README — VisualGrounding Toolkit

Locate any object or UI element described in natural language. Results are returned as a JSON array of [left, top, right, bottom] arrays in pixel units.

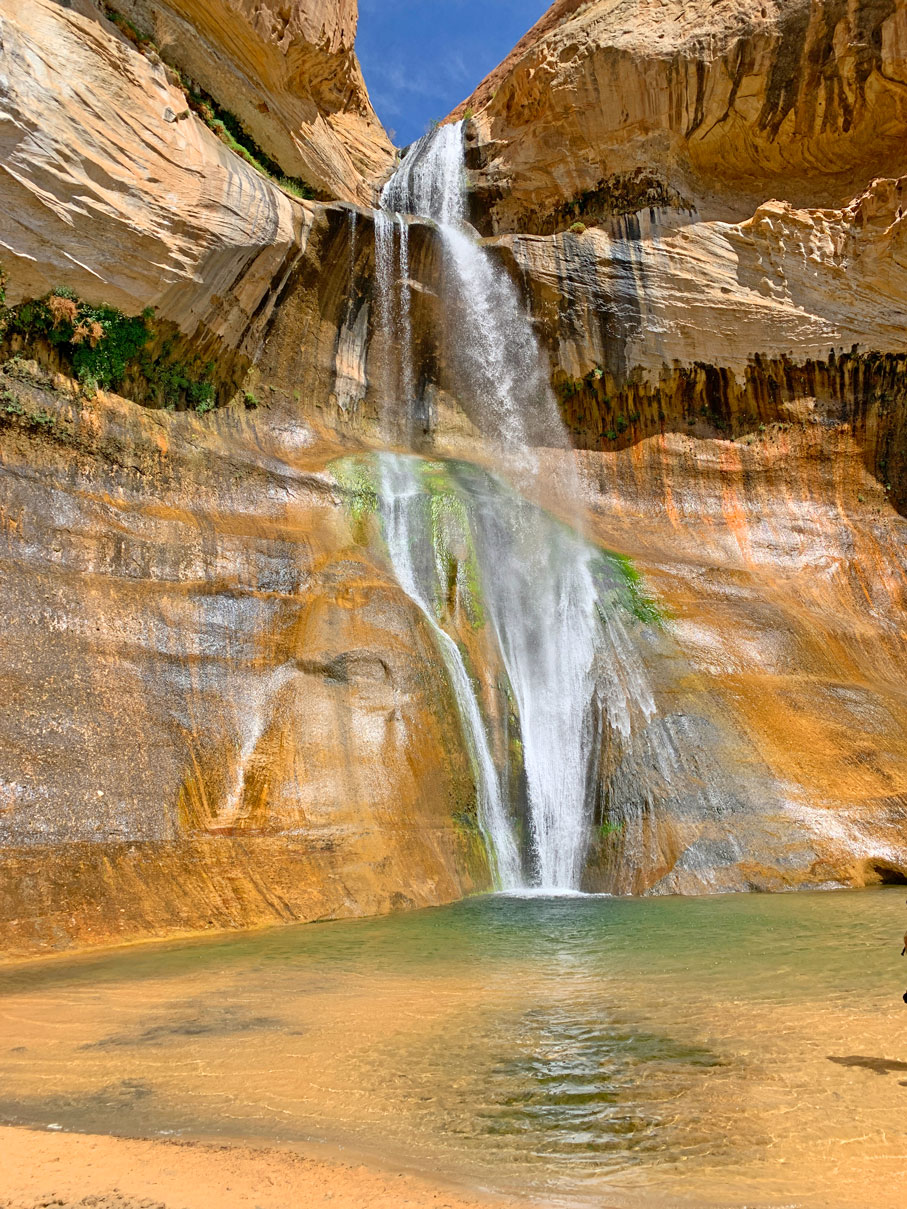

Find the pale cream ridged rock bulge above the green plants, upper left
[[0, 0, 298, 353]]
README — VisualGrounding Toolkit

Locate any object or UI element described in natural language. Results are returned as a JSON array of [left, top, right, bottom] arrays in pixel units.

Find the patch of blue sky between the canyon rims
[[356, 0, 550, 146]]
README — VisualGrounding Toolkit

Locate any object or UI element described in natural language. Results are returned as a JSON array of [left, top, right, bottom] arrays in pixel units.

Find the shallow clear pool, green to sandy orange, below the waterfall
[[0, 889, 907, 1209]]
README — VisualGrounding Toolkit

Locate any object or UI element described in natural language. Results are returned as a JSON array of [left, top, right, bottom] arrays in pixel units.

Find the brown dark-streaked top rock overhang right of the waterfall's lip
[[458, 0, 907, 232]]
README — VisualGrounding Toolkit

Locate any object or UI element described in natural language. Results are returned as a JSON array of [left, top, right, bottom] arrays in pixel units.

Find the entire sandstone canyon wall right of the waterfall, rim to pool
[[445, 0, 907, 891]]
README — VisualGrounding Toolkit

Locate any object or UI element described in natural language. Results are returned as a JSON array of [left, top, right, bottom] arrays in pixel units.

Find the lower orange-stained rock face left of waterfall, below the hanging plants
[[0, 366, 487, 953]]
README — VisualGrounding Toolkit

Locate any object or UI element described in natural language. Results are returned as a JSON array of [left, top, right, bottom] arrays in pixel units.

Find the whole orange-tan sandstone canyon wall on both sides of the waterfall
[[0, 0, 907, 953]]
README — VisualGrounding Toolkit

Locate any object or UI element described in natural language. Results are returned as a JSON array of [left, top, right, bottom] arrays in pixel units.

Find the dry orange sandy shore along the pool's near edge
[[0, 1126, 525, 1209]]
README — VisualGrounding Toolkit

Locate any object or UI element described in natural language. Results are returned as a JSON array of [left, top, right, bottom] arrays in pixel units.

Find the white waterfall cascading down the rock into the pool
[[376, 125, 653, 891]]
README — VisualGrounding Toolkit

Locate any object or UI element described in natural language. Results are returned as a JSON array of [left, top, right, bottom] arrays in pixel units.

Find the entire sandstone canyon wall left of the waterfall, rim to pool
[[0, 0, 489, 954]]
